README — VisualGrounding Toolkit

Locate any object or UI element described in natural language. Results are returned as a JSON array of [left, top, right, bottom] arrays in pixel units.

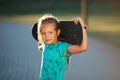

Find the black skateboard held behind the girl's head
[[32, 21, 83, 45]]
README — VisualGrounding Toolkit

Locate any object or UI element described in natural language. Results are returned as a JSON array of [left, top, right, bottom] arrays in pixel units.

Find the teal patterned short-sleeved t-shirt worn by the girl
[[40, 41, 72, 80]]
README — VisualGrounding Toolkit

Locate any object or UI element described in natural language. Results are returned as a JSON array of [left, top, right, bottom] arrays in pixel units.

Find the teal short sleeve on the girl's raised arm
[[60, 42, 72, 58]]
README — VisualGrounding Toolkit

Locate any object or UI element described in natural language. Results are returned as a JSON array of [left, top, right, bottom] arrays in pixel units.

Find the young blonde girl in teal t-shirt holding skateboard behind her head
[[38, 15, 88, 80]]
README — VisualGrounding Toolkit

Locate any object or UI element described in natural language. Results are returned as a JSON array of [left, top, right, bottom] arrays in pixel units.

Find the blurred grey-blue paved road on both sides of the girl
[[0, 22, 120, 80]]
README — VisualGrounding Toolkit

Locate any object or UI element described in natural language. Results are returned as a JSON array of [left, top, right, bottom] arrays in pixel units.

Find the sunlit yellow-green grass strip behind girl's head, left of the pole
[[0, 14, 79, 24]]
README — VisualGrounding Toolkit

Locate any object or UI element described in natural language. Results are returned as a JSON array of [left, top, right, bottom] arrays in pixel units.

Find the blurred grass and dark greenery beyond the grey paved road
[[0, 0, 120, 46]]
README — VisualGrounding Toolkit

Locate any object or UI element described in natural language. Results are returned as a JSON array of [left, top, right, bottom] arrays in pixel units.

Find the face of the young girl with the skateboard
[[40, 23, 60, 44]]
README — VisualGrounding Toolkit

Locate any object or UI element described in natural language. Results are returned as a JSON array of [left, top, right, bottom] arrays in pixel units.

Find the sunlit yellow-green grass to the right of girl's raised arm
[[88, 16, 120, 47]]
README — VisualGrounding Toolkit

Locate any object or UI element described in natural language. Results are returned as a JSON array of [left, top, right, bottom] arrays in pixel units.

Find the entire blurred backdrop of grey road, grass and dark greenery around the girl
[[0, 0, 120, 80]]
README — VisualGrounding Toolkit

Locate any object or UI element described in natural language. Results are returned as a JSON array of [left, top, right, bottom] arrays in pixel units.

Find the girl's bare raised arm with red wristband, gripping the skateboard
[[68, 17, 88, 54]]
